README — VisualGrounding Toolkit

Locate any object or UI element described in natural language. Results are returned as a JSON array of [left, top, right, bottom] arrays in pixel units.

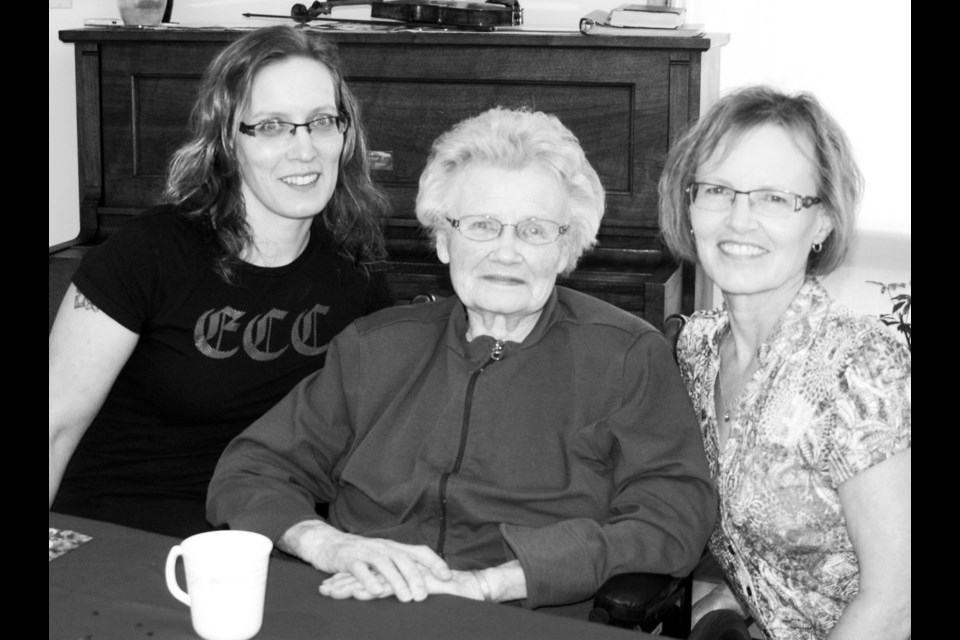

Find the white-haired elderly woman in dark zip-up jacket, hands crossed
[[207, 109, 716, 615]]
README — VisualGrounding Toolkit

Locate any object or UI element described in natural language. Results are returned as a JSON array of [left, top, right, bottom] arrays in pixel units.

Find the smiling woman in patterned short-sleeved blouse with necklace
[[660, 87, 911, 640]]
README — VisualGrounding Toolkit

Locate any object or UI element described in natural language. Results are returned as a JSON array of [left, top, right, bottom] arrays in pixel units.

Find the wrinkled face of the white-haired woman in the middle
[[437, 164, 568, 319]]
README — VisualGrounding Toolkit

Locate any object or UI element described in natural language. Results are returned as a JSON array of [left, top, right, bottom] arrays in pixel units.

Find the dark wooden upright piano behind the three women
[[59, 24, 728, 327]]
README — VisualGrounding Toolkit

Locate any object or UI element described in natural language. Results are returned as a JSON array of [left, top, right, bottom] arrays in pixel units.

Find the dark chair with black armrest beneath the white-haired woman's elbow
[[589, 314, 751, 640]]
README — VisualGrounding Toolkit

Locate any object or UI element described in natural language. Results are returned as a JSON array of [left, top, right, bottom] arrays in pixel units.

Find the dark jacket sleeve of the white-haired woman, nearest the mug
[[207, 325, 356, 542]]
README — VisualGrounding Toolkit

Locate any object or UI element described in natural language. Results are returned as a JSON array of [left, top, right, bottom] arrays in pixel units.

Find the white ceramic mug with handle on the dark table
[[166, 530, 273, 640]]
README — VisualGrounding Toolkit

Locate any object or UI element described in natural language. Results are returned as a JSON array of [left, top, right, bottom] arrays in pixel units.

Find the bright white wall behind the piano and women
[[49, 0, 911, 313]]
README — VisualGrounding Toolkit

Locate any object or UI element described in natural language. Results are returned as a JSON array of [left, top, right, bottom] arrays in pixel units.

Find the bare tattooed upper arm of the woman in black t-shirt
[[48, 284, 139, 507]]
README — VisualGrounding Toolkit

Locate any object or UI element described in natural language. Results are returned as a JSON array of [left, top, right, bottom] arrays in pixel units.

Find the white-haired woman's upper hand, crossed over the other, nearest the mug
[[277, 520, 452, 602]]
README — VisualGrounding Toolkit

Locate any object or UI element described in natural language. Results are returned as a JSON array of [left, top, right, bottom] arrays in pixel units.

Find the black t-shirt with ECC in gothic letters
[[52, 208, 393, 537]]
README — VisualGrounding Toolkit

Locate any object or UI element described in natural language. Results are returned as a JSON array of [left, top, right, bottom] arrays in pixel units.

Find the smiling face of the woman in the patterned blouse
[[690, 124, 833, 295]]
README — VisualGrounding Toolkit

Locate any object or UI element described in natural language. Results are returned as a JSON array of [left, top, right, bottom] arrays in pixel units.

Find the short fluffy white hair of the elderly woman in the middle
[[416, 107, 604, 275]]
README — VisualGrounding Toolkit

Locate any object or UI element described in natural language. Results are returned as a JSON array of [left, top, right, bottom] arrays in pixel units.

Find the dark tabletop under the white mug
[[49, 513, 654, 640]]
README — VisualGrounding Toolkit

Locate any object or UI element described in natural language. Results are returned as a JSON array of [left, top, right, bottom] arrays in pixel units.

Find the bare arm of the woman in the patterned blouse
[[830, 449, 911, 640]]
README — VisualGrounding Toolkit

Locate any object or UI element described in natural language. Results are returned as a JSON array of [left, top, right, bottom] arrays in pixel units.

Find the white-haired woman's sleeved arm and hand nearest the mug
[[207, 341, 451, 602]]
